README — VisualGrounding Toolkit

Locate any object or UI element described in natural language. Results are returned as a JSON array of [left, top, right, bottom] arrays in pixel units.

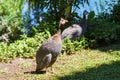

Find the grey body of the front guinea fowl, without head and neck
[[36, 32, 62, 70]]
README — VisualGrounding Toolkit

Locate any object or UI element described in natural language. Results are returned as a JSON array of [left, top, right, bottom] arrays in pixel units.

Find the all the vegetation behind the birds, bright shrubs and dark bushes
[[0, 0, 120, 61]]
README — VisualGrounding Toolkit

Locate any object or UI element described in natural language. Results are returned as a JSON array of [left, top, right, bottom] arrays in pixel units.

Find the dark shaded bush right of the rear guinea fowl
[[86, 14, 120, 45]]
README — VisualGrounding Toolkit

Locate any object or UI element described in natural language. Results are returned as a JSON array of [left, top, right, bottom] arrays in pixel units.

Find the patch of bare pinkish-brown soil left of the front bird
[[0, 58, 36, 80]]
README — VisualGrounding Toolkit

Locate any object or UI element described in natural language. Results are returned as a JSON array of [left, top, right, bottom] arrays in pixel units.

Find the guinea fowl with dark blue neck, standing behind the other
[[62, 10, 88, 41]]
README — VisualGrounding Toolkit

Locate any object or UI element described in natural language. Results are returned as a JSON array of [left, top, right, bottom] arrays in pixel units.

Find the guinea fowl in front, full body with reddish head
[[36, 18, 68, 72]]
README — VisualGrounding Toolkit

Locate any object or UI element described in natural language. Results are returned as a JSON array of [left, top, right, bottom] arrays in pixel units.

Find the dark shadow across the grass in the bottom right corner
[[58, 61, 120, 80]]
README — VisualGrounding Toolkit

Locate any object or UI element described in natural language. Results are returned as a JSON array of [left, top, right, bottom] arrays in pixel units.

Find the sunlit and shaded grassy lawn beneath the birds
[[0, 44, 120, 80]]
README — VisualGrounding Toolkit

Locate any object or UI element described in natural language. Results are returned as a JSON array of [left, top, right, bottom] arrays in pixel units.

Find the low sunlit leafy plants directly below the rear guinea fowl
[[62, 36, 89, 55]]
